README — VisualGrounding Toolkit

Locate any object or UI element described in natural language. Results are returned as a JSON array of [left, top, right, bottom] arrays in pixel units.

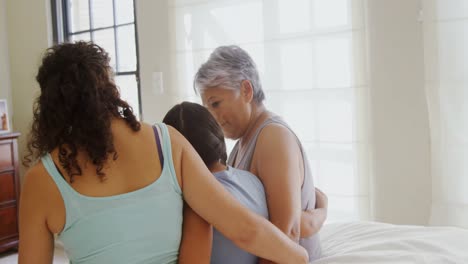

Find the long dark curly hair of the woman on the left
[[23, 41, 141, 182]]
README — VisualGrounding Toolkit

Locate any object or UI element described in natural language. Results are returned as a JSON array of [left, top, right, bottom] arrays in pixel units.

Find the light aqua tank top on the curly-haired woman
[[42, 124, 183, 264]]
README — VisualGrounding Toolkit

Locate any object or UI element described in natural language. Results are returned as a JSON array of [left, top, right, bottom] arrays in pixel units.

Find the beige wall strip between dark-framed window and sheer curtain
[[136, 0, 179, 123]]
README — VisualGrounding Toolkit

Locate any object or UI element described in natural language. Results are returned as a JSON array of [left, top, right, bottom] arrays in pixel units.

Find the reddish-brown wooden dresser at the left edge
[[0, 133, 20, 252]]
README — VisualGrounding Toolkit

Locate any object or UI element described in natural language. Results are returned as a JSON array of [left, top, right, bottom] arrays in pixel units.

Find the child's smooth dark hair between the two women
[[163, 102, 227, 167]]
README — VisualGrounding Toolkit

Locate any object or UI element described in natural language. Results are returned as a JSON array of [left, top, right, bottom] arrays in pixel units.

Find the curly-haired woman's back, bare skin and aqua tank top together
[[34, 121, 183, 263]]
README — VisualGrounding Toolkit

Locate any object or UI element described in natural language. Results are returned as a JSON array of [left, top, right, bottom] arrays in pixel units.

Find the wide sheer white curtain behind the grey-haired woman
[[169, 0, 370, 220]]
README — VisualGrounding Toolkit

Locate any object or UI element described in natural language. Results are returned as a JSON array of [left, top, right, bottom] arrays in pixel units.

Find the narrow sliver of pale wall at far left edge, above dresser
[[0, 0, 13, 120]]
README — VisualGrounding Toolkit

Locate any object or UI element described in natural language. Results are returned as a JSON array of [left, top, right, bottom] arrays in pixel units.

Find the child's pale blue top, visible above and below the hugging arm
[[211, 167, 268, 264]]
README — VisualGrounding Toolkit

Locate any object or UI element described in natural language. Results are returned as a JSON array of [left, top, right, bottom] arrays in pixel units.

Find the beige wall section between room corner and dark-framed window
[[2, 0, 51, 178]]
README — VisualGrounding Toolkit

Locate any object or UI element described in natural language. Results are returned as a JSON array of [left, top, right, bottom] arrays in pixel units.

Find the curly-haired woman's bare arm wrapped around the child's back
[[169, 128, 308, 263]]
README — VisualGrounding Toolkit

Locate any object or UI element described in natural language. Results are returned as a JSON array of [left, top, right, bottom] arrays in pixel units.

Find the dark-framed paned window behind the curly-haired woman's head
[[52, 0, 141, 118]]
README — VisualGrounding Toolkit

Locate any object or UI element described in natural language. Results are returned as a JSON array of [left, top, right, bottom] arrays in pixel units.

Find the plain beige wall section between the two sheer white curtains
[[367, 0, 431, 224]]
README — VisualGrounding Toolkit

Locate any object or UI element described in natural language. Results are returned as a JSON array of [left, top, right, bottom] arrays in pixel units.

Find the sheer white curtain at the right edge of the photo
[[423, 0, 468, 228]]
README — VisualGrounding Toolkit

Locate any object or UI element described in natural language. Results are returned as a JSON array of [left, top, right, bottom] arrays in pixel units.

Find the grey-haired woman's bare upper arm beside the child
[[252, 125, 304, 263]]
